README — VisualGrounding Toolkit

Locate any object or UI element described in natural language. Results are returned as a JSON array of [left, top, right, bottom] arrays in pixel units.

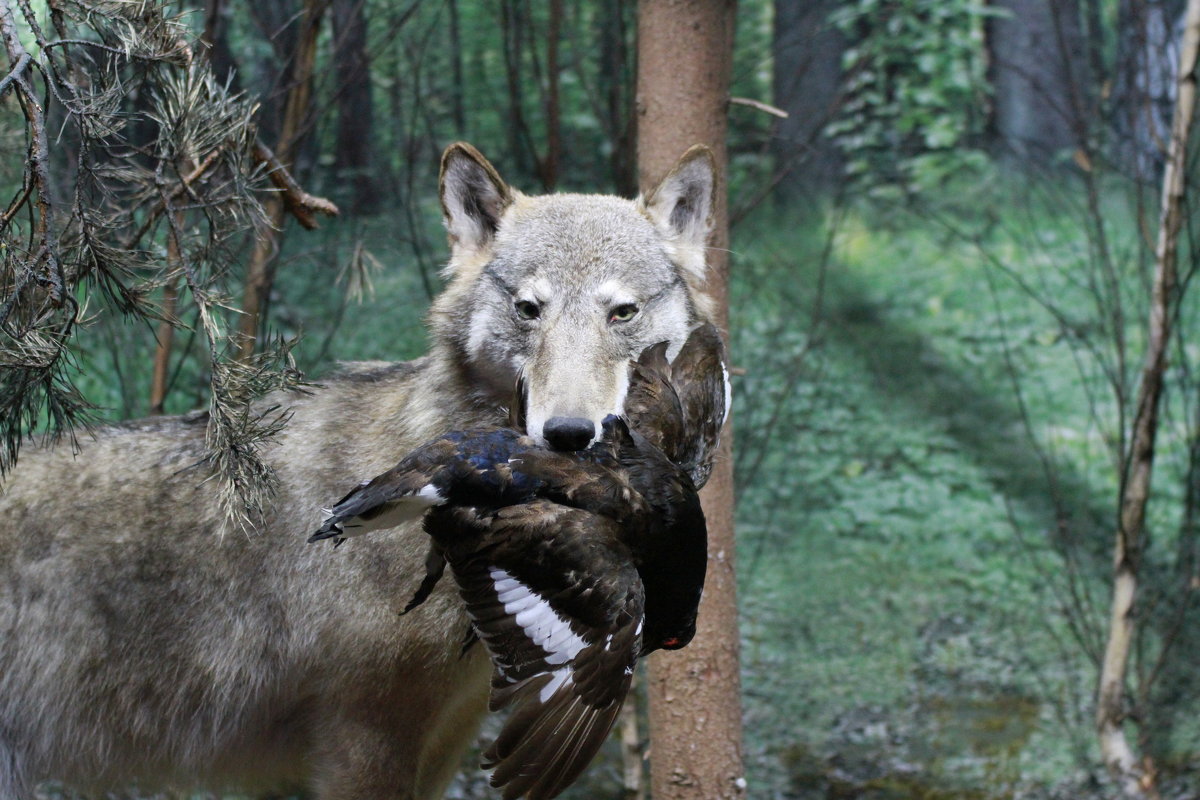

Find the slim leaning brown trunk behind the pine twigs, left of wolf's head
[[238, 0, 329, 361]]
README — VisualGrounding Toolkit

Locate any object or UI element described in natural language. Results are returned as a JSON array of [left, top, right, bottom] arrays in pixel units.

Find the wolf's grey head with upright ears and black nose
[[432, 143, 715, 450]]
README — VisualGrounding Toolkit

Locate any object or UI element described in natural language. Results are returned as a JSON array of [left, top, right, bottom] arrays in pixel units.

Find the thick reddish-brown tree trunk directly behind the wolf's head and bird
[[637, 0, 746, 800]]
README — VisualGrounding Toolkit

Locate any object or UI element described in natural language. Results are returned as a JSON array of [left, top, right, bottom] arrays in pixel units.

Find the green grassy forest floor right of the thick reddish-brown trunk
[[731, 183, 1198, 798]]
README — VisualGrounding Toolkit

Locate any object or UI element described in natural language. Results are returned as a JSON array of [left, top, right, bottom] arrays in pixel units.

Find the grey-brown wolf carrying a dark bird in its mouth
[[0, 144, 714, 800]]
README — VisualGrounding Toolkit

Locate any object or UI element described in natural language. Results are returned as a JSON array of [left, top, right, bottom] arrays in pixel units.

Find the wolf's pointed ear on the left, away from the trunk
[[439, 142, 512, 252]]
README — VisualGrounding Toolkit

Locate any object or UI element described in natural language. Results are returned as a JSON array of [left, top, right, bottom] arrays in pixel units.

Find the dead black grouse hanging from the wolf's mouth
[[310, 325, 728, 800]]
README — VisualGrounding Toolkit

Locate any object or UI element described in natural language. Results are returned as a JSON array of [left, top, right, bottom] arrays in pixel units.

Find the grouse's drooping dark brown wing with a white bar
[[427, 500, 644, 800]]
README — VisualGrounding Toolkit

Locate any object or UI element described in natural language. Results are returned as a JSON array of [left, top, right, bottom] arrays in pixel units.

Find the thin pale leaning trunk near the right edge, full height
[[1096, 0, 1200, 798]]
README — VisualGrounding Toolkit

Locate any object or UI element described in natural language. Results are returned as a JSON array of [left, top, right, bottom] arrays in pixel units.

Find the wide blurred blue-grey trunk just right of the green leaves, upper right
[[986, 0, 1087, 164]]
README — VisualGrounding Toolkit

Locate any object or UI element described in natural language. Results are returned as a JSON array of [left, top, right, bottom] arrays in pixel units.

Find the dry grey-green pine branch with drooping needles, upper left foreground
[[0, 0, 302, 528]]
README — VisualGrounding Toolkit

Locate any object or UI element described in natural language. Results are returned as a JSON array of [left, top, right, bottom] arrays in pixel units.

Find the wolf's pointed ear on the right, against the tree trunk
[[640, 144, 716, 249]]
